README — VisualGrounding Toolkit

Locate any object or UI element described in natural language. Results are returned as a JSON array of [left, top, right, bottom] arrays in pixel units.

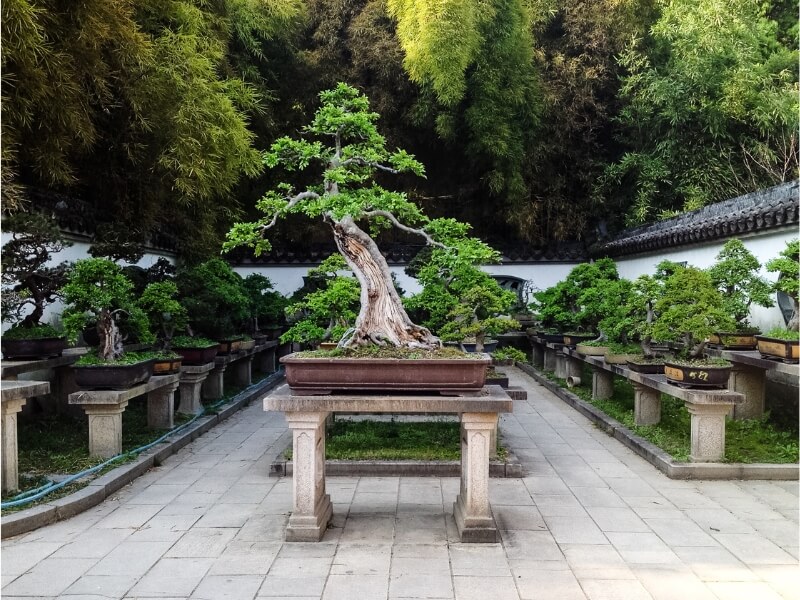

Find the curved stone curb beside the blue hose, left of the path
[[0, 371, 284, 539]]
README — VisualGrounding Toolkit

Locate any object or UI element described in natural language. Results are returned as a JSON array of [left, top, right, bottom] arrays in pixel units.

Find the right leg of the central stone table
[[453, 413, 497, 543]]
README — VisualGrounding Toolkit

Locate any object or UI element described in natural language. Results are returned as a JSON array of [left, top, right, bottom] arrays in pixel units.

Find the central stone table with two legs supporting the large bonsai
[[264, 385, 513, 542]]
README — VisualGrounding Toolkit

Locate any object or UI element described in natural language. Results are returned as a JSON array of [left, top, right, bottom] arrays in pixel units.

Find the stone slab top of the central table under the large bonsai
[[264, 385, 514, 413]]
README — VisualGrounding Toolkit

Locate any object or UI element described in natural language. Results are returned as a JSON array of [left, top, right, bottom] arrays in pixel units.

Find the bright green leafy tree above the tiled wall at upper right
[[603, 0, 798, 223]]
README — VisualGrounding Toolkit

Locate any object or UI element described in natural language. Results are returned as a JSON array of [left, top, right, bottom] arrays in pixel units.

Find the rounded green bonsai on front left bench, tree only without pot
[[62, 258, 153, 361]]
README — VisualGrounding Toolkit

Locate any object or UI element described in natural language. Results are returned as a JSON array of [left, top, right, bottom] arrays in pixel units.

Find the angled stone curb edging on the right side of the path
[[517, 363, 798, 481]]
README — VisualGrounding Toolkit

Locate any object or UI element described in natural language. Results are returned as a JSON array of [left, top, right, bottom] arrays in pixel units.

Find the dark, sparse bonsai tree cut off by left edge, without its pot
[[2, 213, 71, 337]]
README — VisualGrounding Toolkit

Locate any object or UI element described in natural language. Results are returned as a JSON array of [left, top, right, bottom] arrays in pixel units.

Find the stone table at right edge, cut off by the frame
[[706, 348, 800, 419]]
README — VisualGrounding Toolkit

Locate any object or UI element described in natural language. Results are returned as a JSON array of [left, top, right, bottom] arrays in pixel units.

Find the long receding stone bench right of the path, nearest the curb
[[562, 348, 744, 462]]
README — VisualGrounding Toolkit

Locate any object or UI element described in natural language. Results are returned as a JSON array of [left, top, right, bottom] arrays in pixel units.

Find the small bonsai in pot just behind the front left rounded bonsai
[[138, 281, 187, 375]]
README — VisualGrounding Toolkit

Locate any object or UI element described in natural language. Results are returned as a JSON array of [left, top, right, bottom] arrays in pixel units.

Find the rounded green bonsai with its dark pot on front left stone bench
[[62, 258, 154, 389]]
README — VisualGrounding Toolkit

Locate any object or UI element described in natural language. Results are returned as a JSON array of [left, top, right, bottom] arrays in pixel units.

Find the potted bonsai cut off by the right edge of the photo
[[756, 239, 800, 362]]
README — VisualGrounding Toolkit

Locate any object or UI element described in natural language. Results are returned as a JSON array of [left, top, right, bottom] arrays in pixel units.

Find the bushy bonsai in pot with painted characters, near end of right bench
[[653, 267, 733, 387]]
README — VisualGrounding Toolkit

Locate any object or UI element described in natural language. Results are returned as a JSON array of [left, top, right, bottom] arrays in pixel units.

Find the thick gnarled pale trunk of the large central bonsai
[[332, 217, 441, 349]]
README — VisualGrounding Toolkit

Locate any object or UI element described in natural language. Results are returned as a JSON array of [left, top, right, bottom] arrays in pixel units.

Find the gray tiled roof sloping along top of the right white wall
[[593, 180, 800, 257]]
